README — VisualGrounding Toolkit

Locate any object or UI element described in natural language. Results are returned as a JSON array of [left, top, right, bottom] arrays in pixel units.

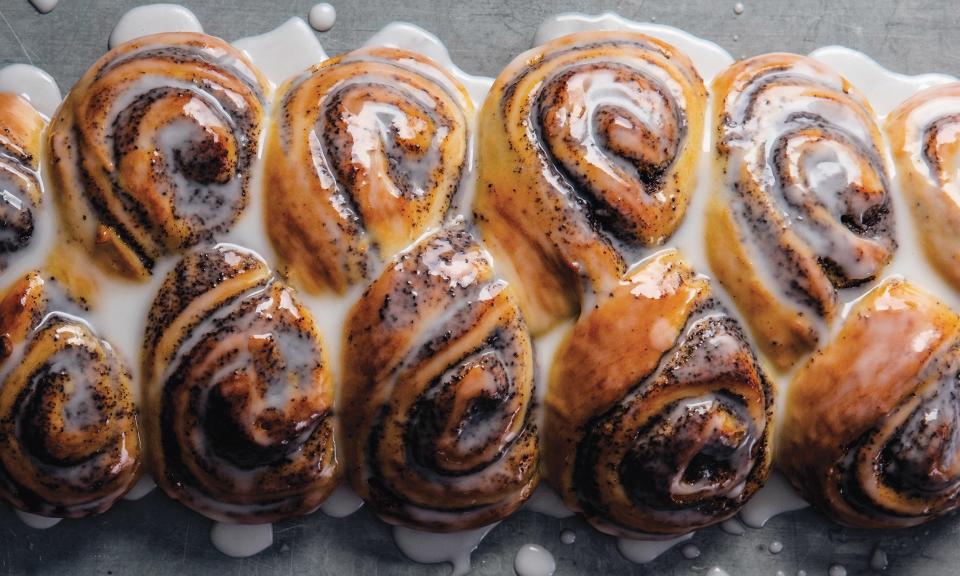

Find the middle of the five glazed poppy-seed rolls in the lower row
[[341, 225, 539, 532]]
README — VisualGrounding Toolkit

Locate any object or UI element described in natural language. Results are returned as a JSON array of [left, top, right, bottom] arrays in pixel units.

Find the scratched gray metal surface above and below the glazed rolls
[[0, 0, 960, 576]]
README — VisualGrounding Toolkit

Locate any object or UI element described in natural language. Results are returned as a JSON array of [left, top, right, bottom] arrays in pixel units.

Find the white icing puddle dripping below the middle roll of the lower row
[[393, 524, 496, 576]]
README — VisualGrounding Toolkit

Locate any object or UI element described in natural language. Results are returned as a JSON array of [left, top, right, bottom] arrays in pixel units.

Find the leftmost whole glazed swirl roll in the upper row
[[49, 33, 267, 279]]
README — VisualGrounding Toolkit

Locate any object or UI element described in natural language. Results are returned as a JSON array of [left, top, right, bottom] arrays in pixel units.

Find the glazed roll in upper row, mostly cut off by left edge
[[0, 92, 46, 272]]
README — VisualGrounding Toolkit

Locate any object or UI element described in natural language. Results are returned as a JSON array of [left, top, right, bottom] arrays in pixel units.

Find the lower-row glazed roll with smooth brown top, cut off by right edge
[[778, 280, 960, 528]]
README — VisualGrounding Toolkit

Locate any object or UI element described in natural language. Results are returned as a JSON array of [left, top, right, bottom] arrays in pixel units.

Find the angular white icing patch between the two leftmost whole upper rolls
[[233, 17, 327, 86]]
